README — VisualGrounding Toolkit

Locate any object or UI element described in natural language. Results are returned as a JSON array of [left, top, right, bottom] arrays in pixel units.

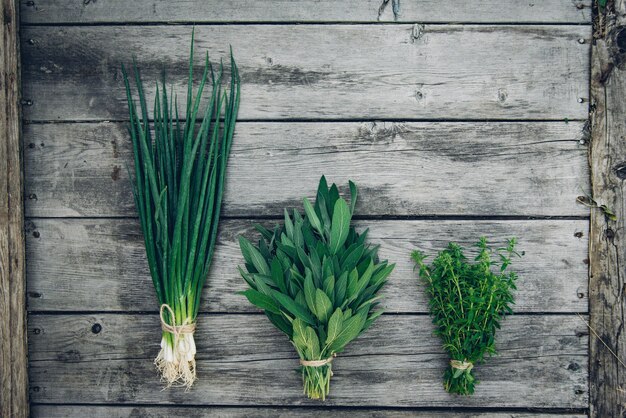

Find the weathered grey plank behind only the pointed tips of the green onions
[[17, 24, 591, 120]]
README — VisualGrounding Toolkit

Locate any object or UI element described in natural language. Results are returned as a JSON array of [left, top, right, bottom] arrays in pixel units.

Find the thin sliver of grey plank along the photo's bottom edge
[[31, 405, 587, 418]]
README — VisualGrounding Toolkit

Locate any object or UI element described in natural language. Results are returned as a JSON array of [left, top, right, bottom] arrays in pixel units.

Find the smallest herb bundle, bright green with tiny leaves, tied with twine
[[411, 237, 519, 395]]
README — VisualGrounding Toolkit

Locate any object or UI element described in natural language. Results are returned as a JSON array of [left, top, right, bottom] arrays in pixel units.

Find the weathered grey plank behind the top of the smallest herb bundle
[[27, 219, 589, 312]]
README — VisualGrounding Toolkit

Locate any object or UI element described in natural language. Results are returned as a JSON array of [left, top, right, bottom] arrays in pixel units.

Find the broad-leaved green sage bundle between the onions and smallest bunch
[[239, 176, 394, 400]]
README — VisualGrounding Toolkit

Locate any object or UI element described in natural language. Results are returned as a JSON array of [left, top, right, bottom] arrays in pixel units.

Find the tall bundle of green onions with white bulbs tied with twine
[[122, 34, 240, 388]]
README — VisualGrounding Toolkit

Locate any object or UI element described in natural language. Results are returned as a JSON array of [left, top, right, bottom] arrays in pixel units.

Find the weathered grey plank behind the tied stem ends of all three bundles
[[29, 314, 588, 408]]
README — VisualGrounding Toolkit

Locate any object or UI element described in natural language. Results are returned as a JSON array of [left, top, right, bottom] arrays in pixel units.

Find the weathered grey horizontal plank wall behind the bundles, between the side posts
[[21, 0, 591, 418]]
